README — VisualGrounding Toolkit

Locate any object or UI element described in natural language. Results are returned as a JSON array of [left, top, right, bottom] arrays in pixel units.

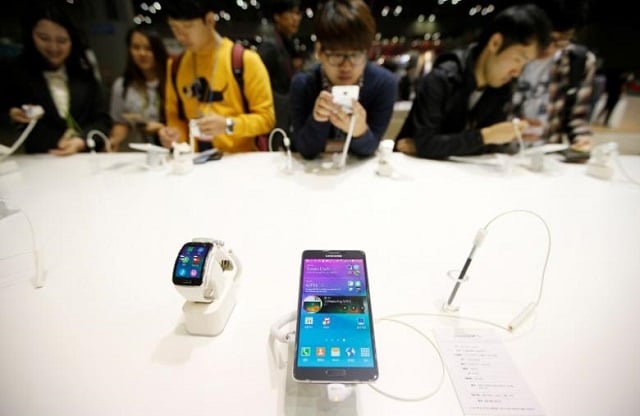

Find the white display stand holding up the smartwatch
[[182, 279, 237, 337]]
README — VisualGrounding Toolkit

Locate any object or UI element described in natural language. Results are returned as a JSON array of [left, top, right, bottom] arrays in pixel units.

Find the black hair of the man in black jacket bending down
[[478, 4, 551, 55]]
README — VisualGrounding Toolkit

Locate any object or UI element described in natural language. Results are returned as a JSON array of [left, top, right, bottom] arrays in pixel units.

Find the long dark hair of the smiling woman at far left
[[21, 2, 95, 78]]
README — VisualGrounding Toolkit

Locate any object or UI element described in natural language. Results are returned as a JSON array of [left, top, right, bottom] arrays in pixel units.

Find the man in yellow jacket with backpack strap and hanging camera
[[158, 0, 275, 152]]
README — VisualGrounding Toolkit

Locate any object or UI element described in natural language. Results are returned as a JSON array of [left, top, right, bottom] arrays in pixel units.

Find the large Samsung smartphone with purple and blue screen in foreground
[[293, 250, 378, 383]]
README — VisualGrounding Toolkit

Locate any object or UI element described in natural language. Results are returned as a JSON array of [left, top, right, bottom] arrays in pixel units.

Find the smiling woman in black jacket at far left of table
[[0, 3, 111, 156]]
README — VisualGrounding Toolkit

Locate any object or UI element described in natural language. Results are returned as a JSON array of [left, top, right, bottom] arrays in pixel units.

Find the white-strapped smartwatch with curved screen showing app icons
[[172, 238, 236, 303]]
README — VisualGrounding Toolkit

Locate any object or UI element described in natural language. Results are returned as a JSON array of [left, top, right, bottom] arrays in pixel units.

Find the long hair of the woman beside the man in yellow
[[122, 26, 169, 108]]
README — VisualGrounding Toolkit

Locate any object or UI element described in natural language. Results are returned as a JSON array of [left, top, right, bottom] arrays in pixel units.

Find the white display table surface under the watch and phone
[[0, 153, 640, 416]]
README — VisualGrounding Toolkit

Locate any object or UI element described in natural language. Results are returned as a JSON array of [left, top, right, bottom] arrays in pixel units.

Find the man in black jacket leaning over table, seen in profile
[[396, 4, 551, 159]]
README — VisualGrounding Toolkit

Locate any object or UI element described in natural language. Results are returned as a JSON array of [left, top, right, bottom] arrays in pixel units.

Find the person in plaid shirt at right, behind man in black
[[513, 0, 596, 158]]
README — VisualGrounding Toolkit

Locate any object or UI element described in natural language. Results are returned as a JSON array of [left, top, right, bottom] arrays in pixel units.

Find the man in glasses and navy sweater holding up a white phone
[[290, 0, 397, 159]]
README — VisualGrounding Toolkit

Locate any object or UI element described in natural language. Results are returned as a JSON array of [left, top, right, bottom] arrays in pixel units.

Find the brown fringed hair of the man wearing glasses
[[314, 0, 376, 50]]
